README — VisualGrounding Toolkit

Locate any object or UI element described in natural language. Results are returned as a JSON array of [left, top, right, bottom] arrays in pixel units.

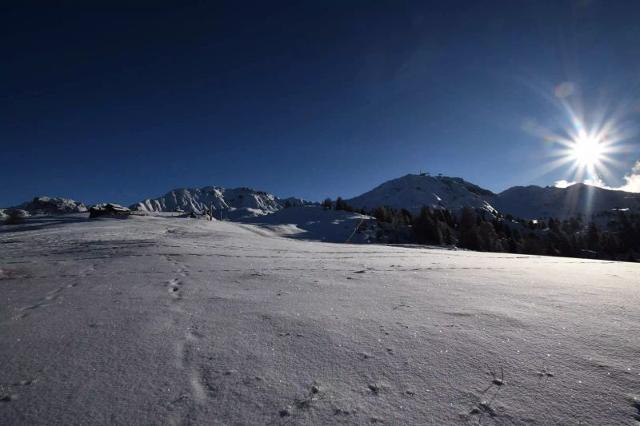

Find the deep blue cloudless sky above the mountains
[[0, 0, 640, 206]]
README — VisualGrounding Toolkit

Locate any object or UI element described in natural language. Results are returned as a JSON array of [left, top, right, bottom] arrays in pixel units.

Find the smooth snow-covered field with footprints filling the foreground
[[0, 216, 640, 425]]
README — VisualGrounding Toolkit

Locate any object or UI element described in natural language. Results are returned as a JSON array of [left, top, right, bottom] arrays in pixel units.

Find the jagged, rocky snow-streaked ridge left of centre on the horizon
[[131, 186, 312, 220]]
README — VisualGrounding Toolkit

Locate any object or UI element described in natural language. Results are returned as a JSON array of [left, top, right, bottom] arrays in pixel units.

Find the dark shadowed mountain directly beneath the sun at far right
[[488, 183, 640, 219]]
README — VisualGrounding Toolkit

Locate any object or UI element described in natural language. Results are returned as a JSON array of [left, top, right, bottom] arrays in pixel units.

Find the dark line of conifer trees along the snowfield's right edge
[[322, 197, 640, 261]]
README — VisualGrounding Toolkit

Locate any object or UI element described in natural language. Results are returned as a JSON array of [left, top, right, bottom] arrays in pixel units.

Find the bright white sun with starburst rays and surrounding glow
[[521, 81, 640, 208]]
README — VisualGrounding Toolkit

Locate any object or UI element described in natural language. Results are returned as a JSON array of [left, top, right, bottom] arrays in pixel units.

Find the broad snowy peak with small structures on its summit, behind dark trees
[[347, 174, 495, 213]]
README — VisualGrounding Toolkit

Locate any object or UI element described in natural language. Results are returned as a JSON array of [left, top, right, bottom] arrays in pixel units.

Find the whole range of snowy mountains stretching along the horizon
[[5, 174, 640, 220]]
